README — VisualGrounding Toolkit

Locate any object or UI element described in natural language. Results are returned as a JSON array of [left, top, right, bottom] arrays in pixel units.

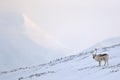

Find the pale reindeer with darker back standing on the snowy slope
[[93, 49, 109, 66]]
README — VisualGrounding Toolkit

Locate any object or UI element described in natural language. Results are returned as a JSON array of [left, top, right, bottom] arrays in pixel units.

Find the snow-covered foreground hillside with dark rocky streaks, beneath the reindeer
[[0, 37, 120, 80]]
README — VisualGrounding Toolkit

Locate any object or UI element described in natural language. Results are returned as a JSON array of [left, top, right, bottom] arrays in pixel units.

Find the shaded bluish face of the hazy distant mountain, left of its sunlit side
[[0, 12, 64, 71]]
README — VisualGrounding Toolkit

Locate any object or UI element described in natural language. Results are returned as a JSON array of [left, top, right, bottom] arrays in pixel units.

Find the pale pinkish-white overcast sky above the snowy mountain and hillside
[[0, 0, 120, 51]]
